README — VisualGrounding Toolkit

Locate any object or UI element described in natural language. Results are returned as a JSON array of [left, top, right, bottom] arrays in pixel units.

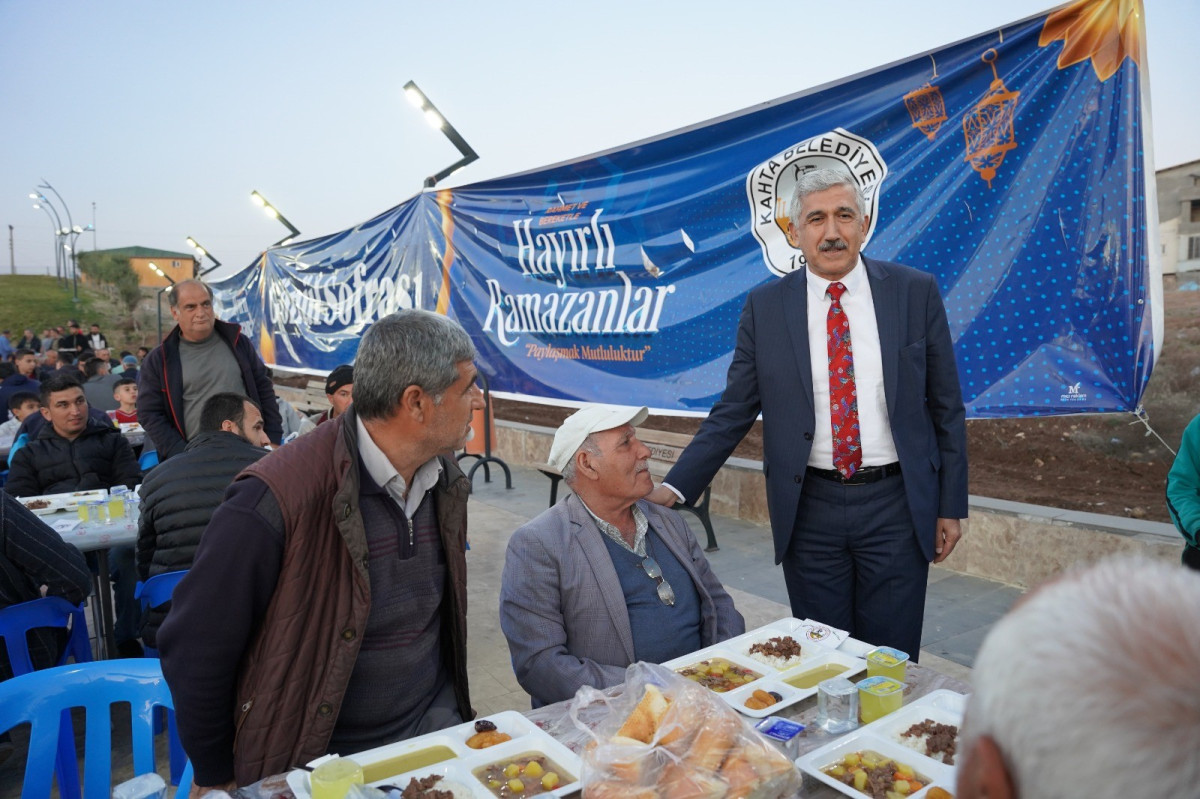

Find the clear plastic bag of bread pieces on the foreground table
[[570, 663, 800, 799]]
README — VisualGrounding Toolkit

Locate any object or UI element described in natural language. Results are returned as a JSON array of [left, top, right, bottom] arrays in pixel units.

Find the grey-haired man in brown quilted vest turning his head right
[[158, 311, 484, 795]]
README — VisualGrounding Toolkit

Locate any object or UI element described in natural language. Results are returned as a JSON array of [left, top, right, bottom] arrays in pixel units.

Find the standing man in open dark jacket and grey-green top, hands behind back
[[138, 280, 283, 461]]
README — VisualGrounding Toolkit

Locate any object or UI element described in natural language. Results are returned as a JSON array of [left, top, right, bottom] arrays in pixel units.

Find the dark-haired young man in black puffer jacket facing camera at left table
[[4, 376, 142, 657]]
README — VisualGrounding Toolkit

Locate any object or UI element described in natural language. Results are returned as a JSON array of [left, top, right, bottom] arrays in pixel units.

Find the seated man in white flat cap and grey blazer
[[500, 404, 745, 708]]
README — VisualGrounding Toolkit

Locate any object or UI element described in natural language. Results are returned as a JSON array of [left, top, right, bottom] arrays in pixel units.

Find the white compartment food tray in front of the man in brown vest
[[288, 710, 582, 799]]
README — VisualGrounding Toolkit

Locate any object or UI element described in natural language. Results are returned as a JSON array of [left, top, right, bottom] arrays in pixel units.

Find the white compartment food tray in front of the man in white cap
[[662, 619, 870, 719]]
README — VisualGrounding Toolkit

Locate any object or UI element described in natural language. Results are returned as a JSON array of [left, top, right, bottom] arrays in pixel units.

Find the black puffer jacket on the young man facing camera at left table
[[4, 417, 142, 497]]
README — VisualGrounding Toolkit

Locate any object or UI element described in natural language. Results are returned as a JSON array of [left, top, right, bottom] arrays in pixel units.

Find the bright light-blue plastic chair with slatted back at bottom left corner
[[0, 657, 191, 799]]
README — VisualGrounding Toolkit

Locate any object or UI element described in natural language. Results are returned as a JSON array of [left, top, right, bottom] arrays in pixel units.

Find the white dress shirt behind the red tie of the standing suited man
[[808, 258, 900, 469]]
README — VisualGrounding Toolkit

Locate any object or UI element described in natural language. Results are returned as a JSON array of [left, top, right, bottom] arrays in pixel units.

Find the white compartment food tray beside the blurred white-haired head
[[796, 689, 967, 799]]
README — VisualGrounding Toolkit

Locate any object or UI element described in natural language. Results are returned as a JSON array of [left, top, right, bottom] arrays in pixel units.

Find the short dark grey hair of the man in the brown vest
[[354, 310, 476, 419]]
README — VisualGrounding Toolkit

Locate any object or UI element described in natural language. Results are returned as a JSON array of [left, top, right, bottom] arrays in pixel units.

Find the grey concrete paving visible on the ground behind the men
[[0, 461, 1021, 799]]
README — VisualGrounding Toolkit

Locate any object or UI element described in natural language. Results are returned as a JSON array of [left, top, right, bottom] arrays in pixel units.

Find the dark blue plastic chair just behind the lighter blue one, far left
[[0, 596, 91, 795]]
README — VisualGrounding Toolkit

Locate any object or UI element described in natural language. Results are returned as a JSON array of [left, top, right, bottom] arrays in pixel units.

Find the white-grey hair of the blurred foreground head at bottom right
[[959, 557, 1200, 799]]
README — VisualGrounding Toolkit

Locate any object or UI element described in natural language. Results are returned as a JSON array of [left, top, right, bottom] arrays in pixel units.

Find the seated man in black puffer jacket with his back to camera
[[138, 394, 269, 647]]
